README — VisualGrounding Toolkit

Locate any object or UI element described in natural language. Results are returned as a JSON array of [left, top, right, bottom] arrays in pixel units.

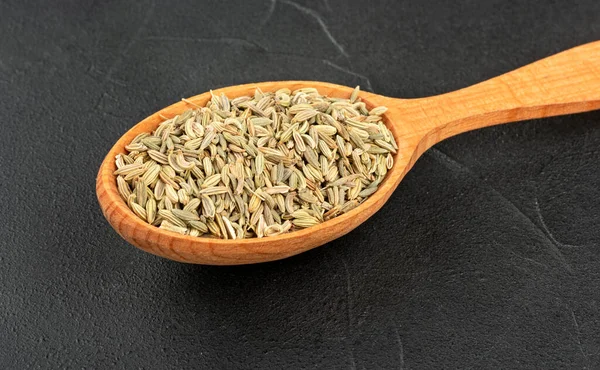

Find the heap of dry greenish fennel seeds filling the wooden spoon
[[114, 87, 398, 239]]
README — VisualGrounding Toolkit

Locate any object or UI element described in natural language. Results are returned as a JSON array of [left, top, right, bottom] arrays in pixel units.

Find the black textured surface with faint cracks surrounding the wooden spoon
[[0, 0, 600, 369]]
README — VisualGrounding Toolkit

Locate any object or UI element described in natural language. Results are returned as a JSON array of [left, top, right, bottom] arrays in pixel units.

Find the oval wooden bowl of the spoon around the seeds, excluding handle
[[96, 81, 412, 265]]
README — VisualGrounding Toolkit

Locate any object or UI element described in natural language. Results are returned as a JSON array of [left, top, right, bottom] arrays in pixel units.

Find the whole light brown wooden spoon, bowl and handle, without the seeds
[[96, 41, 600, 265]]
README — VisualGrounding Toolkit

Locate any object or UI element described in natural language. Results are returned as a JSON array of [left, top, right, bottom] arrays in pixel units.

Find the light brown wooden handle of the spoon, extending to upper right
[[398, 41, 600, 142]]
